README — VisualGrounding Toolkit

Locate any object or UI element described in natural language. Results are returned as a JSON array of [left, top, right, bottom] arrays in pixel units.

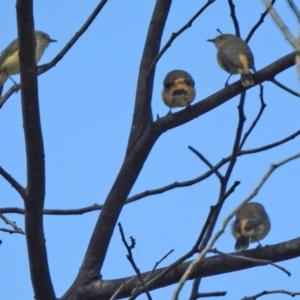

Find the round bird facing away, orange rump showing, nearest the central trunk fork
[[161, 70, 196, 113]]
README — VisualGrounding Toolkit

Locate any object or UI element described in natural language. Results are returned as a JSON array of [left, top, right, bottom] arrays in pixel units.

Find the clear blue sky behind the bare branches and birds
[[0, 0, 300, 300]]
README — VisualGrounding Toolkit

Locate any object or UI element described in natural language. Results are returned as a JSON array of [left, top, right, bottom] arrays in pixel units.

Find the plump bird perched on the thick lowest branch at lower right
[[231, 202, 271, 251]]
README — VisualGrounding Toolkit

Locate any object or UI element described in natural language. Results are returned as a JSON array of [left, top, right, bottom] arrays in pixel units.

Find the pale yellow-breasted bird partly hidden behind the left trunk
[[0, 31, 57, 97]]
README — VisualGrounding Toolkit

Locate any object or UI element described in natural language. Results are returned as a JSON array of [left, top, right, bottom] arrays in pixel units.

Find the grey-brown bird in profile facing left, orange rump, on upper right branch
[[207, 34, 255, 87]]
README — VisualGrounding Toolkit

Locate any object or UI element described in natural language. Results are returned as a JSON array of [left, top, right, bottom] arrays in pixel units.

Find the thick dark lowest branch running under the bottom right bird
[[90, 238, 300, 300]]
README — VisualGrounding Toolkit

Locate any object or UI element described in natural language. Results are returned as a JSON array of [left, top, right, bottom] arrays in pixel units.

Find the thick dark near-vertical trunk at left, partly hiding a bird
[[16, 0, 56, 300]]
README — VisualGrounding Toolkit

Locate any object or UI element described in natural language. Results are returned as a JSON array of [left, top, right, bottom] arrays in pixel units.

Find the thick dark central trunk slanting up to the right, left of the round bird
[[63, 0, 171, 299]]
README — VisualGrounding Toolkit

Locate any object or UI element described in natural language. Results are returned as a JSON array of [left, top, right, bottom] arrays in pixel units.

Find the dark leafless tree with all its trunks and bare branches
[[0, 0, 300, 300]]
